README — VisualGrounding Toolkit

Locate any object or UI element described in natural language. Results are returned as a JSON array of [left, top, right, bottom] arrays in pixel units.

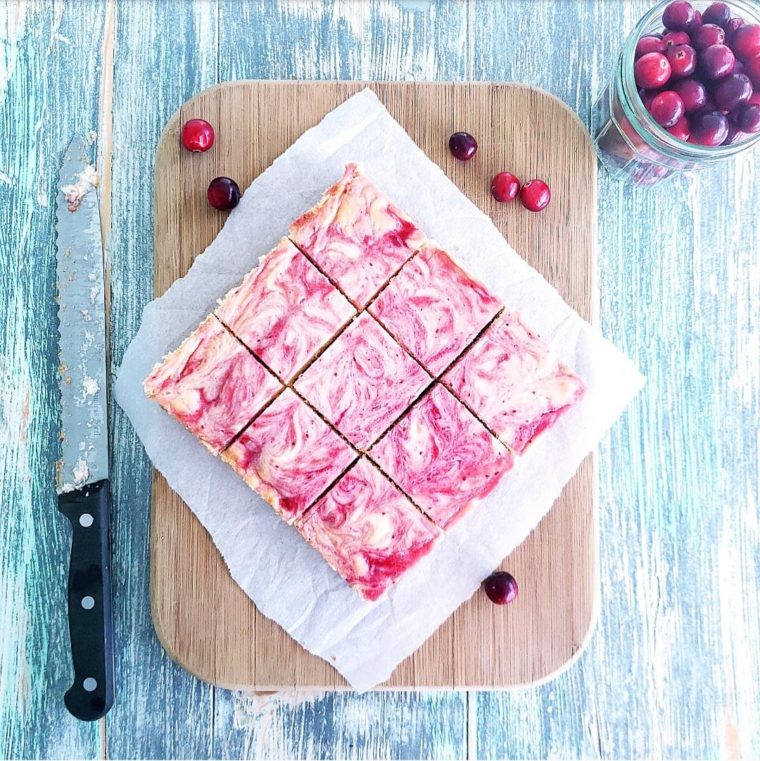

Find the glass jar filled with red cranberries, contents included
[[592, 0, 760, 185]]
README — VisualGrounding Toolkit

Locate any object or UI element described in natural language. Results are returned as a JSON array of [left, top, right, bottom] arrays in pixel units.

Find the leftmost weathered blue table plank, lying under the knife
[[0, 2, 110, 758]]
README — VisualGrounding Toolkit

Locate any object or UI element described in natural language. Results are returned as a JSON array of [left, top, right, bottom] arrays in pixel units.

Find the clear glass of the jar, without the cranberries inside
[[592, 0, 760, 185]]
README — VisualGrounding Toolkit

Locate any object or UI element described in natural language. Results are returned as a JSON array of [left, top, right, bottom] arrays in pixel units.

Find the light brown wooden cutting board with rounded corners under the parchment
[[151, 81, 598, 690]]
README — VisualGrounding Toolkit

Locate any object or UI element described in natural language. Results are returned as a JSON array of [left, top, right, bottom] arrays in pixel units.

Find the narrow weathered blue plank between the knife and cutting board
[[107, 0, 217, 758]]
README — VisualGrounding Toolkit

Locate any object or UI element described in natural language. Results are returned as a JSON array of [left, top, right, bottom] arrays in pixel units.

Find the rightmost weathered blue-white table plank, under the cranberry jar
[[472, 0, 760, 758]]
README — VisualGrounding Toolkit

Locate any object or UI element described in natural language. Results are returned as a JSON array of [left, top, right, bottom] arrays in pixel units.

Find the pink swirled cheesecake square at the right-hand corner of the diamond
[[443, 312, 585, 454]]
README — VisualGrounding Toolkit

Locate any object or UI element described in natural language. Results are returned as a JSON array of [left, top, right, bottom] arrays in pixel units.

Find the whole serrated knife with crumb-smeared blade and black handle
[[55, 135, 113, 721]]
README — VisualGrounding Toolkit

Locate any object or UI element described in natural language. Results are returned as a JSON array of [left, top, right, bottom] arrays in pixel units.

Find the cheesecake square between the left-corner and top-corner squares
[[216, 238, 356, 383]]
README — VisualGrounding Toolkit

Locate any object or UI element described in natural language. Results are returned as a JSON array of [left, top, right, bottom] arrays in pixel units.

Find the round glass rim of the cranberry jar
[[615, 0, 760, 162]]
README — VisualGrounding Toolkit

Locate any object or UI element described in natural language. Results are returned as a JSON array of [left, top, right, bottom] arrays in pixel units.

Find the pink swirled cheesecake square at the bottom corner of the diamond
[[296, 459, 442, 600]]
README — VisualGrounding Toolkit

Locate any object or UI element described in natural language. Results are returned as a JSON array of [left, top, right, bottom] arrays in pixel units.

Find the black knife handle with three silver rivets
[[58, 480, 113, 721]]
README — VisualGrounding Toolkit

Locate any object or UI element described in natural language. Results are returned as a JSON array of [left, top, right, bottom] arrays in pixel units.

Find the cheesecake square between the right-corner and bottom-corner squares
[[369, 383, 514, 529]]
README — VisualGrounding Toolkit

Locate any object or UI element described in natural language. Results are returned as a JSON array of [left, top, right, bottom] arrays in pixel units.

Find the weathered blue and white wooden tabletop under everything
[[0, 0, 760, 758]]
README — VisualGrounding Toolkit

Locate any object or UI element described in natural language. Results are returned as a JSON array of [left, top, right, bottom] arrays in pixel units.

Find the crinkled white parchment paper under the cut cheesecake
[[115, 90, 643, 690]]
